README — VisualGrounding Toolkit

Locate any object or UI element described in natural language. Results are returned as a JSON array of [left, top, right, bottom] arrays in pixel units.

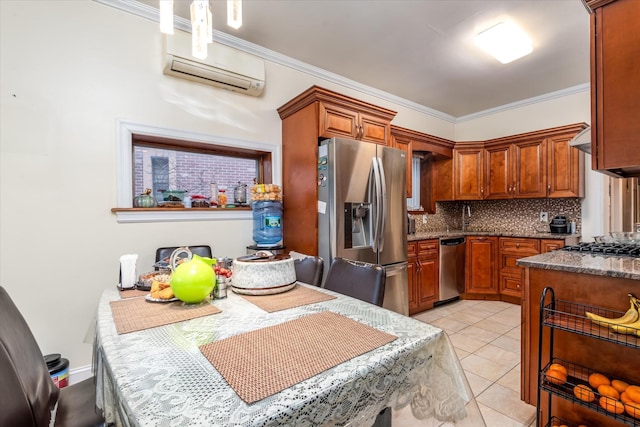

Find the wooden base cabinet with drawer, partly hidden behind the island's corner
[[498, 237, 540, 304]]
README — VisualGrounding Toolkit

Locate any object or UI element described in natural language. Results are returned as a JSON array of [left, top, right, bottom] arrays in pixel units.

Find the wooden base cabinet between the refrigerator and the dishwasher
[[408, 240, 440, 314]]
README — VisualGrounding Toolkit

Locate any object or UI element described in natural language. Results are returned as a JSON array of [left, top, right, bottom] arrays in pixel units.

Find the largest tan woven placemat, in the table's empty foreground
[[200, 311, 397, 403]]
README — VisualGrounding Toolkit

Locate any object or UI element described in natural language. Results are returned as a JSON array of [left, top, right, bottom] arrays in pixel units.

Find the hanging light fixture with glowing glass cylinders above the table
[[159, 0, 242, 59]]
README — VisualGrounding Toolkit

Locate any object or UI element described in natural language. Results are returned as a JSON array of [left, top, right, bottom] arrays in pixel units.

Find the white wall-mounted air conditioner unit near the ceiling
[[163, 31, 265, 96]]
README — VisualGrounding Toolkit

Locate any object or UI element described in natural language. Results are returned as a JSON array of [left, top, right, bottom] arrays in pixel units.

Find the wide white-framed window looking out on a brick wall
[[112, 121, 282, 222]]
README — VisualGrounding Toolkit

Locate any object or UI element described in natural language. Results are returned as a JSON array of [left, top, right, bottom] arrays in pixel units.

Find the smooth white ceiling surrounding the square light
[[134, 0, 589, 118]]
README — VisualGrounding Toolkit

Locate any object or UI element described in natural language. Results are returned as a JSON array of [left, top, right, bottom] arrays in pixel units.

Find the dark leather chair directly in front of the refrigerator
[[324, 257, 386, 307]]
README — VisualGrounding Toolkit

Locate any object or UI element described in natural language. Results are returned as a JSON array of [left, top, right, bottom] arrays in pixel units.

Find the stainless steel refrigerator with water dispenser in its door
[[318, 138, 409, 315]]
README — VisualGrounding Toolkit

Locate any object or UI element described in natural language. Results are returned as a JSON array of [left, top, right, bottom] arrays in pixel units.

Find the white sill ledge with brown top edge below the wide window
[[111, 208, 253, 223]]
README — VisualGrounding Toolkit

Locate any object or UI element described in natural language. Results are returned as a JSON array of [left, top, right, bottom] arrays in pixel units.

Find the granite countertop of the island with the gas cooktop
[[516, 250, 640, 280]]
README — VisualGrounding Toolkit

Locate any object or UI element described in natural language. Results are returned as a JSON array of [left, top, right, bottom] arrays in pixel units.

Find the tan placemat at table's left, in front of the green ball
[[110, 298, 220, 334]]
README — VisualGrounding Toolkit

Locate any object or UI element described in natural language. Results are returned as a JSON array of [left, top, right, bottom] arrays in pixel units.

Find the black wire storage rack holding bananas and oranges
[[537, 287, 640, 427]]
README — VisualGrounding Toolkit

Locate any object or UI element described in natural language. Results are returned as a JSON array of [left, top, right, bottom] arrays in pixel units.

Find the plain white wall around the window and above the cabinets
[[0, 0, 608, 370]]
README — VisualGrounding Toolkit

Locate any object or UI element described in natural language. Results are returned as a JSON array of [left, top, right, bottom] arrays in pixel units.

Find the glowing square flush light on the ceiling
[[476, 22, 533, 64]]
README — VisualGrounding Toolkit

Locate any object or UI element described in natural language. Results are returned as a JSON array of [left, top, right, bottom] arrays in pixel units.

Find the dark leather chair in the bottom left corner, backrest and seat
[[0, 286, 104, 427]]
